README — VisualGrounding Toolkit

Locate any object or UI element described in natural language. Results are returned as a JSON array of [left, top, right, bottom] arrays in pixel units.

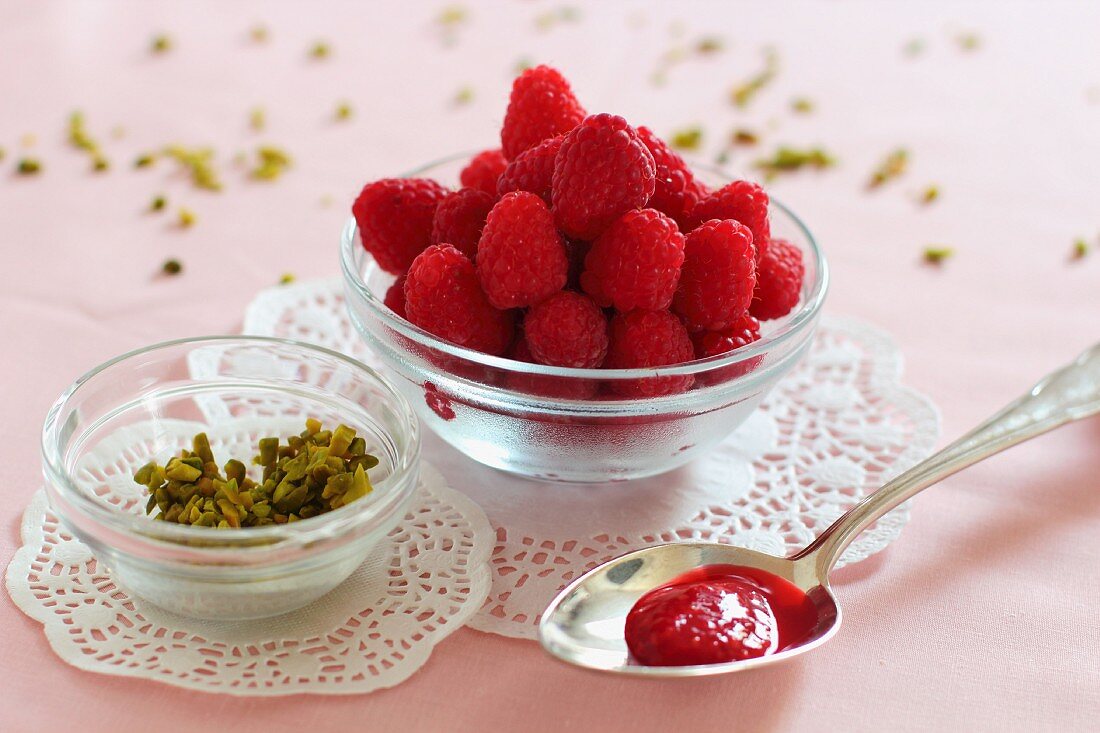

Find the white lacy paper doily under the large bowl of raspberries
[[244, 280, 939, 638]]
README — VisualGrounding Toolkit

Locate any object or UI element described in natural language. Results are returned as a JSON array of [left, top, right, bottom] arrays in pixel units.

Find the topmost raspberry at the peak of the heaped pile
[[501, 66, 585, 161]]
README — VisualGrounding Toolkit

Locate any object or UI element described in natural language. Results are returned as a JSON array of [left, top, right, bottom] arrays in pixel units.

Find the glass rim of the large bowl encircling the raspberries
[[340, 152, 829, 381]]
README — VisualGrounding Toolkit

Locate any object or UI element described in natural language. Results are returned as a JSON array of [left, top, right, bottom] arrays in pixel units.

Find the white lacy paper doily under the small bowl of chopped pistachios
[[6, 413, 494, 696]]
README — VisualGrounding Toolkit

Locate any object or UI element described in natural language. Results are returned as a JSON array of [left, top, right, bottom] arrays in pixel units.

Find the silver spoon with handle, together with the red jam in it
[[539, 343, 1100, 677]]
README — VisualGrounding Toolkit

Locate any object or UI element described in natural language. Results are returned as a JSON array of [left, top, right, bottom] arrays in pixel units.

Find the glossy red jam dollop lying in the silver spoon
[[626, 565, 817, 667]]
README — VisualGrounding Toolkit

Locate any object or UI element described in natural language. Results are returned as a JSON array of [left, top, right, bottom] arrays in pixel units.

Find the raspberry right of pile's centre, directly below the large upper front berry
[[581, 209, 684, 313]]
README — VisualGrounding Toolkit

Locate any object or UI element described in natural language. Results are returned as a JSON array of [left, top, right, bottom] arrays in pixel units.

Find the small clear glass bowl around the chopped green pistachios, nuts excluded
[[42, 337, 420, 620]]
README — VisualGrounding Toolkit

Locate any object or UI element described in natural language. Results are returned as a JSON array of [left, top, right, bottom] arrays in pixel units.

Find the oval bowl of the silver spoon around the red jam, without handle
[[539, 543, 840, 677]]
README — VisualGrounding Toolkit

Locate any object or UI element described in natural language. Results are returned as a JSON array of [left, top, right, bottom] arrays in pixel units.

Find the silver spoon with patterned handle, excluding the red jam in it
[[539, 343, 1100, 677]]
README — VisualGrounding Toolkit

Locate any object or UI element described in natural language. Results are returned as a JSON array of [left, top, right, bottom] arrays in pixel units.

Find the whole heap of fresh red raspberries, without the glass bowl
[[352, 66, 803, 398]]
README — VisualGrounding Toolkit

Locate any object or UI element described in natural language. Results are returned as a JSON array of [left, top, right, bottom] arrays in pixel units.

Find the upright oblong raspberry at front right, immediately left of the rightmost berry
[[672, 219, 756, 331]]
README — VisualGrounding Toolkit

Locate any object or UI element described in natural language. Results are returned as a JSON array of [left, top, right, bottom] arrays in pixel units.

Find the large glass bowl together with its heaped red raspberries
[[341, 66, 828, 482]]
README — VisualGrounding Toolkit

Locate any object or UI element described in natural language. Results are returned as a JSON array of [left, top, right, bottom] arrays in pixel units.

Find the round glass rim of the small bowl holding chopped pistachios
[[41, 335, 420, 545]]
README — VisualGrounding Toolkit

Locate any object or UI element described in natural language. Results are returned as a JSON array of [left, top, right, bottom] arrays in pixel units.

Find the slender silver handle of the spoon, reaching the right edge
[[792, 343, 1100, 579]]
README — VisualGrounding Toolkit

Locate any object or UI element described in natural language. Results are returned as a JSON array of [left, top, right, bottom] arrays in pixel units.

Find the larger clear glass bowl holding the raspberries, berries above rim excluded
[[340, 155, 828, 482]]
